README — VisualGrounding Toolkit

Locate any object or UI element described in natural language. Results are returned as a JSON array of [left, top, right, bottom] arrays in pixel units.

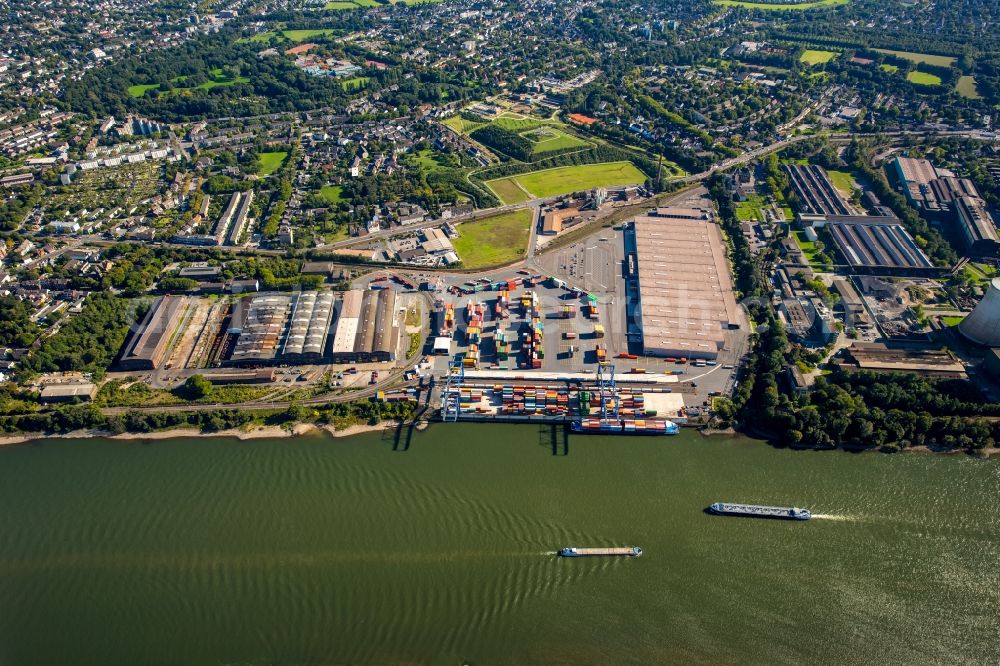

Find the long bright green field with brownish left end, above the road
[[486, 162, 646, 204]]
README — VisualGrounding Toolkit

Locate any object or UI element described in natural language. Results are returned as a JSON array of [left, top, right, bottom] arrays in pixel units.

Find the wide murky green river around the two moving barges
[[0, 424, 1000, 666]]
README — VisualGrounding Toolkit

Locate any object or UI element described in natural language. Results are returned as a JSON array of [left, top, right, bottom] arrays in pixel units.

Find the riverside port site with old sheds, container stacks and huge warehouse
[[107, 189, 748, 434]]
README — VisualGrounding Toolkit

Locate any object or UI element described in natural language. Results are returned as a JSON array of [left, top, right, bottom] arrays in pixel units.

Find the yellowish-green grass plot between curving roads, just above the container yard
[[452, 210, 534, 268]]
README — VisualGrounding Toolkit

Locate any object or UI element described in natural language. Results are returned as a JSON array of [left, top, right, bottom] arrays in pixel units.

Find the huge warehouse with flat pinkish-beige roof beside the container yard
[[633, 208, 737, 359]]
